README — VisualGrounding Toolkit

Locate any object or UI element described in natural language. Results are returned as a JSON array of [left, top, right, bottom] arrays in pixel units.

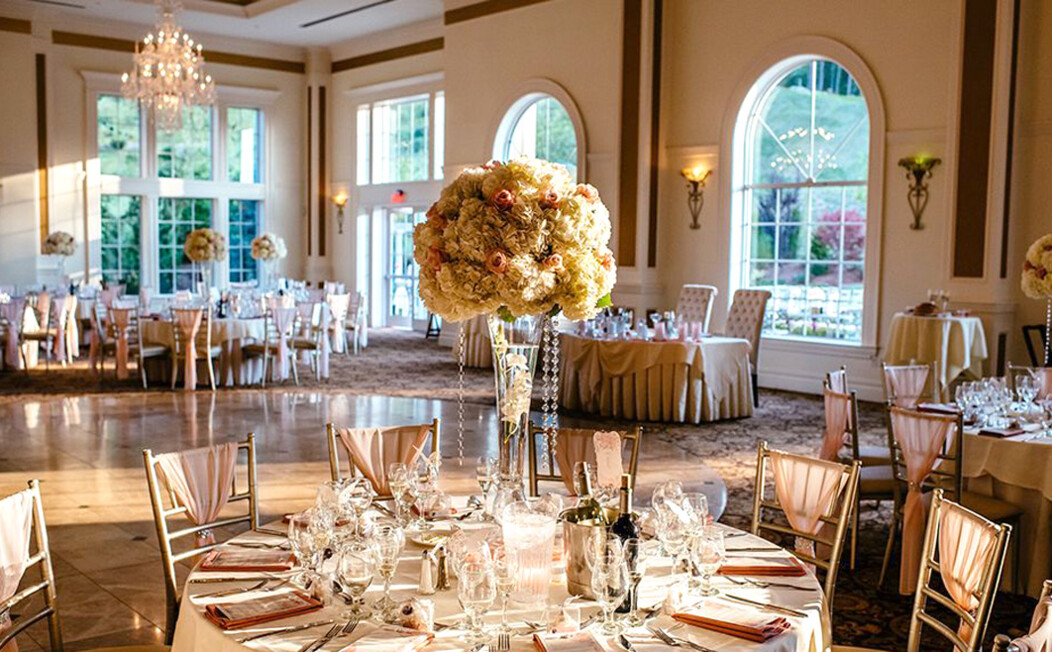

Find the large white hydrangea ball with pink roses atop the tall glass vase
[[413, 157, 616, 322]]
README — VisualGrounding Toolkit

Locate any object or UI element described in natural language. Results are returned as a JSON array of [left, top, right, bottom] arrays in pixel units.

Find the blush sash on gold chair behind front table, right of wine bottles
[[770, 450, 848, 557]]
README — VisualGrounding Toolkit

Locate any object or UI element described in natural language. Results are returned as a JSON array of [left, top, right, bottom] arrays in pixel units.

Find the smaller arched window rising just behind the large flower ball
[[493, 93, 579, 178]]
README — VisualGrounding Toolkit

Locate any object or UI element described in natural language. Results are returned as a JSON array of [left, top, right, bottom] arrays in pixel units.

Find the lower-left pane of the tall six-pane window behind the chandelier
[[99, 195, 142, 293]]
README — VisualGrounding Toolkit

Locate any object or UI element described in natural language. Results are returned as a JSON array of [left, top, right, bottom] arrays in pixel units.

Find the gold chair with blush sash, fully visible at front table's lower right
[[832, 489, 1012, 652]]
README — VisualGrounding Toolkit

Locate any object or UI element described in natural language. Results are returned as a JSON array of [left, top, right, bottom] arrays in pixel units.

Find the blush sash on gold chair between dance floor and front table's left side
[[157, 442, 238, 547]]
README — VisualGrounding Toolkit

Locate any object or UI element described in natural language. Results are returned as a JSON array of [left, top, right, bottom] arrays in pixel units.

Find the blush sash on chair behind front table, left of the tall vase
[[337, 424, 431, 495]]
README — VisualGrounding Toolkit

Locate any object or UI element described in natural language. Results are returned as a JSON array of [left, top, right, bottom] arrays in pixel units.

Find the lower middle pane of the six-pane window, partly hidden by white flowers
[[157, 197, 210, 294]]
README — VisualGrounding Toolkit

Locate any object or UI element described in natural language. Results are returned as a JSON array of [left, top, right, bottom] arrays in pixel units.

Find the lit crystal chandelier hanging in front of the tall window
[[121, 0, 216, 133]]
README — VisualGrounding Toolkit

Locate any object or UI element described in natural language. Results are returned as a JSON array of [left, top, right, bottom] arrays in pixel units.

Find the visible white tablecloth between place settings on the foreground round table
[[171, 521, 831, 652]]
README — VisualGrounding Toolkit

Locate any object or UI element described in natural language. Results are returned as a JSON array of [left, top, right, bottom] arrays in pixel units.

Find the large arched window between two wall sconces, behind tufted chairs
[[732, 57, 870, 343]]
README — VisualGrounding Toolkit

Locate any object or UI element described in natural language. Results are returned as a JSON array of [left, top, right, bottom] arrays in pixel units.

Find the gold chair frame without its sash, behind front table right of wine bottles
[[751, 442, 861, 605]]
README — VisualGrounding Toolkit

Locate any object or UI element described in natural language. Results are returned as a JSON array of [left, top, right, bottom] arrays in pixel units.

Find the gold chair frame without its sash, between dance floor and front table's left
[[142, 432, 260, 645]]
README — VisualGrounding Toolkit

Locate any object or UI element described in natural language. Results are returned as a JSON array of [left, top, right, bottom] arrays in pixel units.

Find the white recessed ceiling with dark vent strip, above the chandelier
[[12, 0, 443, 47]]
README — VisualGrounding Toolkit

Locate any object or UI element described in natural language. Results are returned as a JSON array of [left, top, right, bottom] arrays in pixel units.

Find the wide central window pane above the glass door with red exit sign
[[372, 95, 430, 183]]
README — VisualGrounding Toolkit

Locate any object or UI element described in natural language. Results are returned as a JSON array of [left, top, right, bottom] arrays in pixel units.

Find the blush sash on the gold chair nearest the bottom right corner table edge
[[938, 502, 997, 640]]
